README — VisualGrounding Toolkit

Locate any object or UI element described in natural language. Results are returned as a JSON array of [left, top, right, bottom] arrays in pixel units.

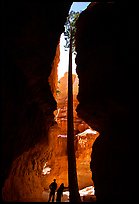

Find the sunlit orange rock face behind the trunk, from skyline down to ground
[[52, 72, 99, 189]]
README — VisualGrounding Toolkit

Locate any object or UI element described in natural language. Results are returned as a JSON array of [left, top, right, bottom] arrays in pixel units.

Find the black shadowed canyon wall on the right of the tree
[[76, 2, 137, 203]]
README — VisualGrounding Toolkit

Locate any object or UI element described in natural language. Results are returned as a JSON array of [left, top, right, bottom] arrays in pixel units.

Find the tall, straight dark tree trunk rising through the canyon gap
[[67, 27, 81, 202]]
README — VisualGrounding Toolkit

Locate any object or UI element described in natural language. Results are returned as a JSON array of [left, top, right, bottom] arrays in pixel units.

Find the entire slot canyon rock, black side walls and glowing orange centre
[[1, 0, 137, 203]]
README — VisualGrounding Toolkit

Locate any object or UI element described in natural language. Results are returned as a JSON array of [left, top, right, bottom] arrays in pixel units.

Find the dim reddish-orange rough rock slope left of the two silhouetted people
[[3, 125, 59, 202]]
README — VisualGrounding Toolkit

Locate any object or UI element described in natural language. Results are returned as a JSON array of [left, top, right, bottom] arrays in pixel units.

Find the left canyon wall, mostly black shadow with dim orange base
[[1, 0, 72, 201]]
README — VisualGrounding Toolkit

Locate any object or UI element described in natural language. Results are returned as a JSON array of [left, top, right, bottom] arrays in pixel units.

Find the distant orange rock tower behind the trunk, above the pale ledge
[[55, 72, 88, 134]]
